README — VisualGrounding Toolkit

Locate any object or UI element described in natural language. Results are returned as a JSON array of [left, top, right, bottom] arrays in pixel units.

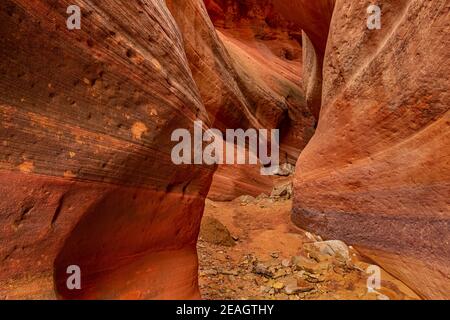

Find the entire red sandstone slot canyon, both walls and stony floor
[[0, 0, 450, 300]]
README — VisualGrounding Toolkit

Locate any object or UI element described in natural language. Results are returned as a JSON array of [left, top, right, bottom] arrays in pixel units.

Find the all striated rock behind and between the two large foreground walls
[[167, 0, 315, 199]]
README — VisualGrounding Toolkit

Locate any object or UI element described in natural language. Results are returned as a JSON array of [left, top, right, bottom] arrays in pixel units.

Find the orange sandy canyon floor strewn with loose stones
[[198, 186, 419, 300]]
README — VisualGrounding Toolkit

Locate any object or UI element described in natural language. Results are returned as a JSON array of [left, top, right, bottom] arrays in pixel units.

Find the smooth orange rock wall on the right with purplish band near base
[[278, 0, 450, 298]]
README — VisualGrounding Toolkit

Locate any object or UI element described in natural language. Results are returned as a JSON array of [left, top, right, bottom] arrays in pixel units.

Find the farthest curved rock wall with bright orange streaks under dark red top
[[205, 0, 315, 164]]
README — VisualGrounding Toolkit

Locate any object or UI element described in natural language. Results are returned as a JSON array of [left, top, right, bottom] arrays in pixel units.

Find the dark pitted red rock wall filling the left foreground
[[0, 0, 214, 299]]
